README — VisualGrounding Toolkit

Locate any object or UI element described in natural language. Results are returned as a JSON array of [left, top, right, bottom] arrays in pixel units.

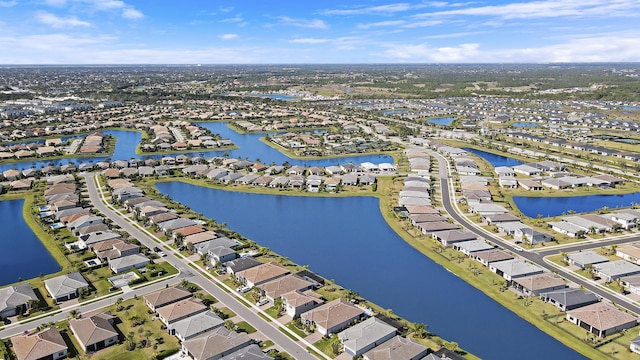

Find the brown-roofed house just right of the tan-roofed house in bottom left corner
[[69, 313, 118, 353]]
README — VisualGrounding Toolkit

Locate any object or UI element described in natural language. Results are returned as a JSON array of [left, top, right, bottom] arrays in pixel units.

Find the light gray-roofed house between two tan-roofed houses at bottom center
[[338, 317, 396, 357]]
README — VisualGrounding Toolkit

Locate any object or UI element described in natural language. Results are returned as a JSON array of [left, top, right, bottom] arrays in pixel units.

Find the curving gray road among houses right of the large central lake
[[431, 152, 640, 315]]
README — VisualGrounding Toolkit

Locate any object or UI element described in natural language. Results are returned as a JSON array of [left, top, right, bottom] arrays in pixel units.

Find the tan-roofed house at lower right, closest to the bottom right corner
[[567, 302, 638, 338]]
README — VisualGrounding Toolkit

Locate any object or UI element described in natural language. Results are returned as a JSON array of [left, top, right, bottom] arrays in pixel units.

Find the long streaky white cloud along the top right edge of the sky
[[416, 0, 640, 19]]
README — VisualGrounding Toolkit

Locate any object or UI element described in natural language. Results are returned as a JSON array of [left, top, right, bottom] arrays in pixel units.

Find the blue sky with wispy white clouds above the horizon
[[0, 0, 640, 64]]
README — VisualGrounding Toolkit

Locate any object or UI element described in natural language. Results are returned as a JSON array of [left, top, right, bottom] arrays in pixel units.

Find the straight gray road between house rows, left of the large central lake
[[83, 173, 317, 360]]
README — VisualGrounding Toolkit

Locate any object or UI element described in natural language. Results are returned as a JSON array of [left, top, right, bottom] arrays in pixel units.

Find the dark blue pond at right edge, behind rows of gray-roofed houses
[[513, 192, 640, 218]]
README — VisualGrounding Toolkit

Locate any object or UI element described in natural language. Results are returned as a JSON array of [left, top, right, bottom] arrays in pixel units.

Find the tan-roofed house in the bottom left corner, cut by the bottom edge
[[11, 328, 68, 360]]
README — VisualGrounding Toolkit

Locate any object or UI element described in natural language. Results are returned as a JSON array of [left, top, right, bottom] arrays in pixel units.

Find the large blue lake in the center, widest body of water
[[157, 182, 583, 359]]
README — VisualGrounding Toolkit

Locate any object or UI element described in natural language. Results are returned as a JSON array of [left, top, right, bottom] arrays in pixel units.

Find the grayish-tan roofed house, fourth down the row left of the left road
[[182, 327, 253, 360]]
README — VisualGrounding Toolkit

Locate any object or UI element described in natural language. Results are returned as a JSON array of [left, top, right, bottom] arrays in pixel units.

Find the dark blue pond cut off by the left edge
[[0, 199, 60, 286]]
